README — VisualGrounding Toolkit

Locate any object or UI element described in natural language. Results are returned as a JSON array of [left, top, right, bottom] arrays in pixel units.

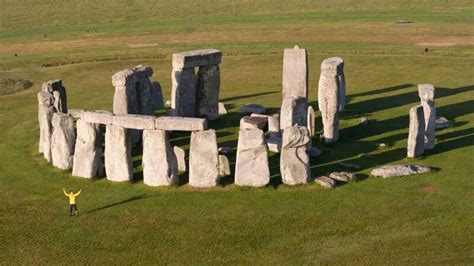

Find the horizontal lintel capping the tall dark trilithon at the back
[[173, 49, 222, 68]]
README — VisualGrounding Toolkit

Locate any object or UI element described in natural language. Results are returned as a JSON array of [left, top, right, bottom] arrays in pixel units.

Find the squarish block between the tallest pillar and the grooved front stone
[[280, 97, 308, 131]]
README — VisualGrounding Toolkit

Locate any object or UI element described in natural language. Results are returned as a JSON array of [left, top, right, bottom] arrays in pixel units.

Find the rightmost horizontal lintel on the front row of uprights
[[155, 116, 207, 131]]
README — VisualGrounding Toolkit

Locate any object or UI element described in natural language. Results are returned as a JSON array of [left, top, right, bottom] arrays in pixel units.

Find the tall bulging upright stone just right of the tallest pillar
[[318, 57, 345, 143]]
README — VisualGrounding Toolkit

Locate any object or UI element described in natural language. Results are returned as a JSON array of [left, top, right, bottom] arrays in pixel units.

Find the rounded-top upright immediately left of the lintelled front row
[[51, 113, 76, 170]]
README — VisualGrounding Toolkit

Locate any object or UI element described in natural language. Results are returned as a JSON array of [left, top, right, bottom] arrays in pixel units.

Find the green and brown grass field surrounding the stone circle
[[0, 0, 474, 264]]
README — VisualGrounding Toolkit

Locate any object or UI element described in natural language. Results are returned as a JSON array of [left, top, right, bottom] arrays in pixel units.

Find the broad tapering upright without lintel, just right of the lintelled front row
[[235, 129, 270, 187]]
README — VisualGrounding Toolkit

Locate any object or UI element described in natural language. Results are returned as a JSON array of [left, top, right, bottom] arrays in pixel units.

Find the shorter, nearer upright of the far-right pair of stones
[[407, 105, 425, 158]]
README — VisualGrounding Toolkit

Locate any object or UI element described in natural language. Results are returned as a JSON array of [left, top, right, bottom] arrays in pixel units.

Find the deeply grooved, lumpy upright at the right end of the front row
[[280, 126, 311, 185]]
